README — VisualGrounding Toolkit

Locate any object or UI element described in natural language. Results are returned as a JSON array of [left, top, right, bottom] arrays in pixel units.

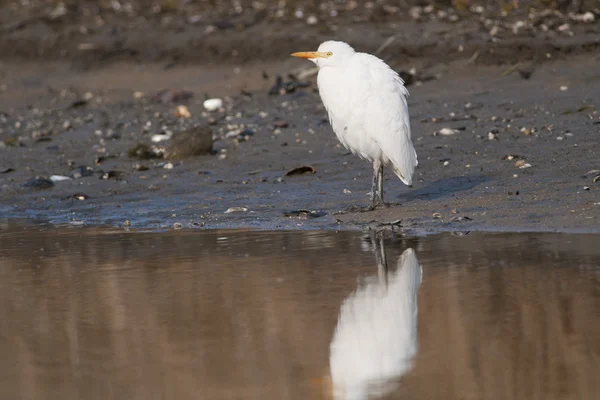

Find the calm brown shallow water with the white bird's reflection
[[0, 220, 600, 400]]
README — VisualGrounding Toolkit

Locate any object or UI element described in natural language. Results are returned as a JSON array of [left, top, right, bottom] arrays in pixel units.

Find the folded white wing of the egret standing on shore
[[361, 53, 418, 185]]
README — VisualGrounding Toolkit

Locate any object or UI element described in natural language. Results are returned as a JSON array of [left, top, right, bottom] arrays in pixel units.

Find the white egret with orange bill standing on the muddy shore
[[292, 41, 417, 209]]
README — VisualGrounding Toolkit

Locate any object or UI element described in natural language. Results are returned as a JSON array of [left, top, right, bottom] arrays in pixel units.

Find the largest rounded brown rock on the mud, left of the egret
[[165, 125, 213, 159]]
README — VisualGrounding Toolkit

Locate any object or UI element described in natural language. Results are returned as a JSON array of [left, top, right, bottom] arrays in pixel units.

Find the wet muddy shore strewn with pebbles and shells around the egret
[[0, 1, 600, 233]]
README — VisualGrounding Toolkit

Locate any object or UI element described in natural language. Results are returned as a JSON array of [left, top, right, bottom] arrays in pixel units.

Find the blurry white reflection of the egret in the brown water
[[329, 239, 422, 400]]
